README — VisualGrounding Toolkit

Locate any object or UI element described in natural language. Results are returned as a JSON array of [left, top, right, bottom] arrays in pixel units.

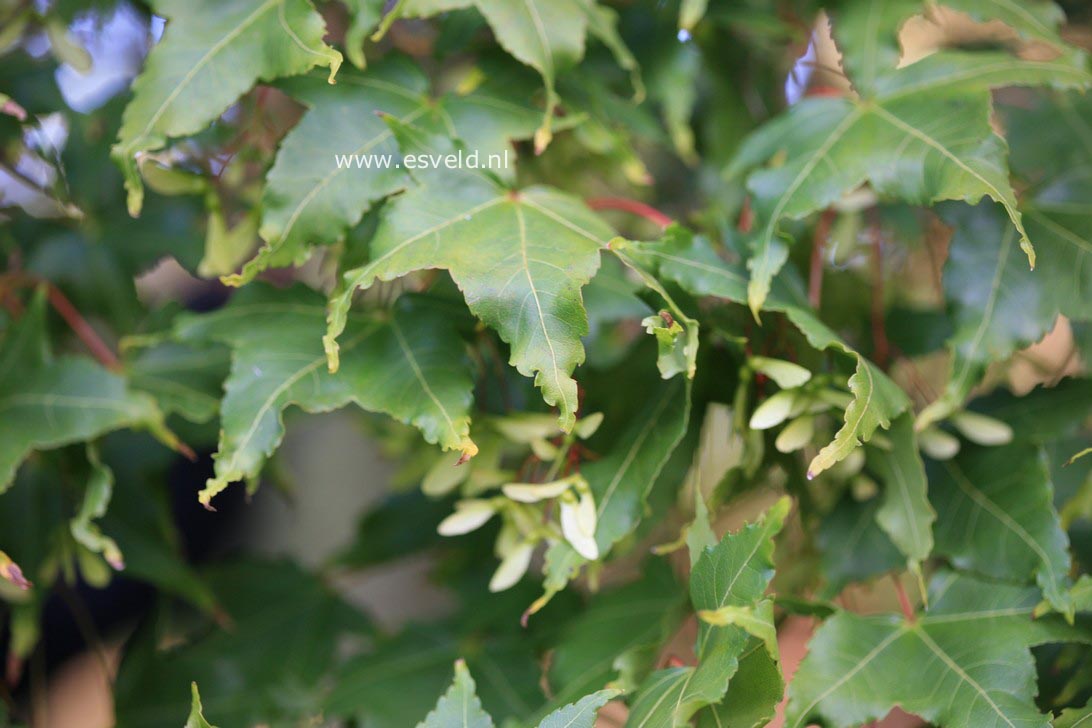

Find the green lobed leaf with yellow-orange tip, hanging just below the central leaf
[[176, 285, 476, 504]]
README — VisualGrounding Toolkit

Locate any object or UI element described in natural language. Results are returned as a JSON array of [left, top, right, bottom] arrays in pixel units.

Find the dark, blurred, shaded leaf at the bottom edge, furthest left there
[[115, 561, 367, 728]]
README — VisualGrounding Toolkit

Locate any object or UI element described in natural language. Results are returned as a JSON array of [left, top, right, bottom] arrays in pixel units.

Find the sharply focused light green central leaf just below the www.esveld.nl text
[[324, 118, 610, 431]]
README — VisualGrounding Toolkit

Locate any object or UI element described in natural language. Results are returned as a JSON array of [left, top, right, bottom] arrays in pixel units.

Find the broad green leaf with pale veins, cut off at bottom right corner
[[785, 572, 1082, 728]]
